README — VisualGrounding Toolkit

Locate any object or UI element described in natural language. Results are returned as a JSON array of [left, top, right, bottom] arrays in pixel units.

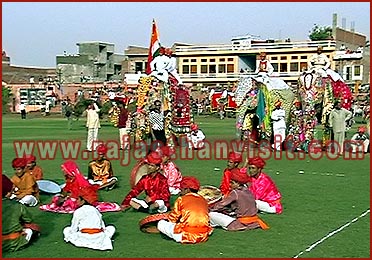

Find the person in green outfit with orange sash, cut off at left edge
[[1, 175, 40, 252]]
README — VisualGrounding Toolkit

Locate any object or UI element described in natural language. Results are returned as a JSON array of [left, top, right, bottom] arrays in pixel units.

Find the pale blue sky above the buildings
[[2, 2, 370, 68]]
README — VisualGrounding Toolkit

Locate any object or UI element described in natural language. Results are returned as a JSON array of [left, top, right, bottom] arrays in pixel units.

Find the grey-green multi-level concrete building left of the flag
[[56, 42, 124, 84]]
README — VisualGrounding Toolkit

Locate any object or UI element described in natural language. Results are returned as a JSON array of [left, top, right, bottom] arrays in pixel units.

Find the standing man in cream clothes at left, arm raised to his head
[[86, 102, 101, 152]]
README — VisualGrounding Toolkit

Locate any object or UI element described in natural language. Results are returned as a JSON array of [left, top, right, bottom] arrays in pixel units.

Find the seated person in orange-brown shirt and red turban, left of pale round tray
[[9, 158, 39, 207]]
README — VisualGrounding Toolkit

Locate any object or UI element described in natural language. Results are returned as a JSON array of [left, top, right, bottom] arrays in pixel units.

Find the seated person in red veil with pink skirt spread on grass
[[39, 161, 120, 213]]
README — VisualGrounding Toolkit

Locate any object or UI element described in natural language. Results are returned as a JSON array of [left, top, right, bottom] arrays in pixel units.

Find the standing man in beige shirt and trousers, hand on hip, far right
[[329, 100, 353, 154]]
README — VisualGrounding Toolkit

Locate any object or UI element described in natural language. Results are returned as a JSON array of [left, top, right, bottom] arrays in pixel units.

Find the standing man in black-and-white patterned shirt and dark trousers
[[149, 100, 167, 150]]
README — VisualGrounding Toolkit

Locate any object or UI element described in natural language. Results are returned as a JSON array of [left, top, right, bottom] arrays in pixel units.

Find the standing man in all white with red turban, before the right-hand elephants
[[271, 100, 286, 151]]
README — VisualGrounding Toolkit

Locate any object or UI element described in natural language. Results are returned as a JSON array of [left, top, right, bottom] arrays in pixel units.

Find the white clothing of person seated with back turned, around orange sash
[[63, 205, 115, 250]]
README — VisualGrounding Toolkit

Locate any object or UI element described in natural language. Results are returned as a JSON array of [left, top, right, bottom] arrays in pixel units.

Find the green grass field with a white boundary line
[[2, 114, 370, 258]]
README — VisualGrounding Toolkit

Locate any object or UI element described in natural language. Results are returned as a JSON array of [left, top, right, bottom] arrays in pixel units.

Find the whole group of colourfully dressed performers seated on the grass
[[2, 145, 283, 251]]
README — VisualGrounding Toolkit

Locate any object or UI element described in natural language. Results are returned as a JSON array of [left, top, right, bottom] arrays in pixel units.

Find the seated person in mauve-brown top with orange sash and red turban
[[209, 171, 269, 231]]
